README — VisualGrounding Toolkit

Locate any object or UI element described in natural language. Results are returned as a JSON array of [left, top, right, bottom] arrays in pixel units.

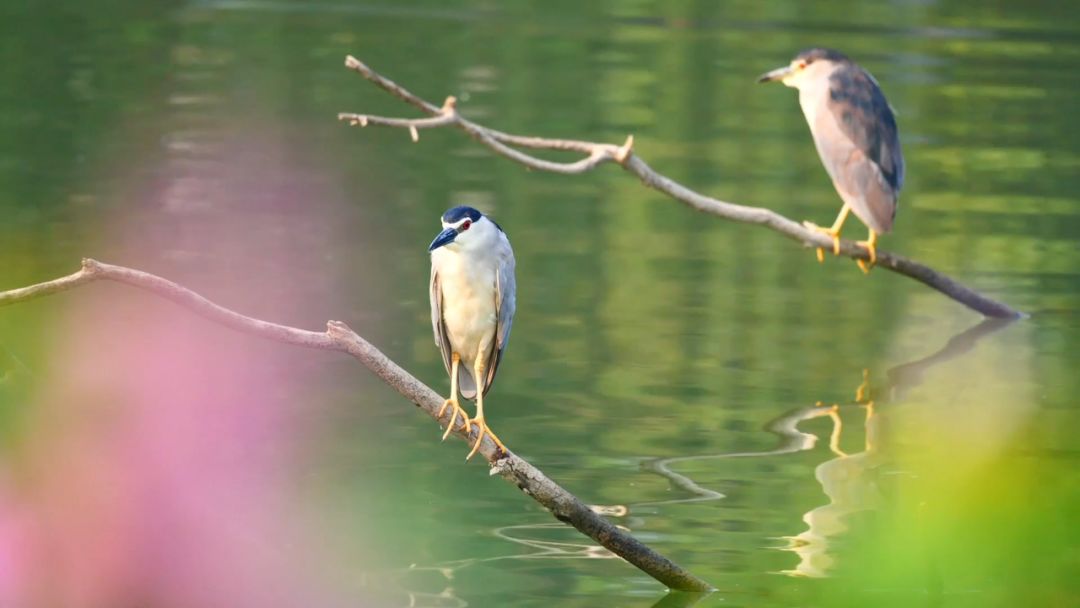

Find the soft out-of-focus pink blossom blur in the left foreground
[[0, 126, 386, 607]]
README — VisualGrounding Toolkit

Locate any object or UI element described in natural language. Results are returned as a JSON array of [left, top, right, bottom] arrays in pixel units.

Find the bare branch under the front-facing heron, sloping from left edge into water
[[0, 258, 713, 592]]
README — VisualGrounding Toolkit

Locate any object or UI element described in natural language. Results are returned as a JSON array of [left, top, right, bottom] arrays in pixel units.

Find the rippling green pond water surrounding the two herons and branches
[[0, 0, 1080, 607]]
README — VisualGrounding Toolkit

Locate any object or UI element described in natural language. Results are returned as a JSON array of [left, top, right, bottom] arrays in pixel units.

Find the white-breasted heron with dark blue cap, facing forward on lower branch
[[428, 206, 517, 460]]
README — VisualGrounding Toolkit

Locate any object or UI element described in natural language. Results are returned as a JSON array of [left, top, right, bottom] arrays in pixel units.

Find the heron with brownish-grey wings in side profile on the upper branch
[[758, 49, 904, 272]]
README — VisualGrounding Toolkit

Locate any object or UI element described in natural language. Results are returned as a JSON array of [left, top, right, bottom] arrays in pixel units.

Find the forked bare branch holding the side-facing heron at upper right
[[338, 55, 1024, 319]]
